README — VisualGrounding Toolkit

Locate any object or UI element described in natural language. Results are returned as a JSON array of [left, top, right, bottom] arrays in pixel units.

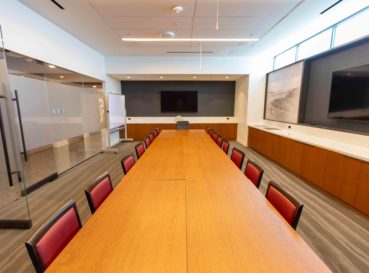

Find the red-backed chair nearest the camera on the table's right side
[[265, 181, 303, 229]]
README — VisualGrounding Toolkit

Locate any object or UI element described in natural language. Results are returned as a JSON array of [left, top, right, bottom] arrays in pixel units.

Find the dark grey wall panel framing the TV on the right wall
[[303, 40, 369, 133]]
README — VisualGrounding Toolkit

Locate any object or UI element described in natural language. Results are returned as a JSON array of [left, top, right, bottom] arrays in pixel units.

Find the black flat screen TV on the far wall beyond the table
[[161, 91, 197, 113]]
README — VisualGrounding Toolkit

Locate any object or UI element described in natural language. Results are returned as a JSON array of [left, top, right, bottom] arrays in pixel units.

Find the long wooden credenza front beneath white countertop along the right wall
[[248, 127, 369, 216]]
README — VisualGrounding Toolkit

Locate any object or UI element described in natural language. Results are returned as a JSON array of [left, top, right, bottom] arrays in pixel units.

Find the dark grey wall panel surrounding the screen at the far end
[[122, 81, 235, 117]]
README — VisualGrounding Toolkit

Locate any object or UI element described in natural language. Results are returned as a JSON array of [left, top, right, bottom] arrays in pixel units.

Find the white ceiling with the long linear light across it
[[19, 0, 303, 56]]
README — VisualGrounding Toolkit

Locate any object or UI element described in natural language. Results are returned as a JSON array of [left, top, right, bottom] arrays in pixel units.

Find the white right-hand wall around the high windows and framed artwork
[[247, 0, 369, 146]]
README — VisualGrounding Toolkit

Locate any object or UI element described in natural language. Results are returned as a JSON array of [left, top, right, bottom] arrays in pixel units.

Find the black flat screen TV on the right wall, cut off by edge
[[328, 65, 369, 121]]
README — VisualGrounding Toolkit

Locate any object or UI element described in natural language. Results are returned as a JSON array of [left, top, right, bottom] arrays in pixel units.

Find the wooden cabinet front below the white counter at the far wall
[[125, 123, 237, 141]]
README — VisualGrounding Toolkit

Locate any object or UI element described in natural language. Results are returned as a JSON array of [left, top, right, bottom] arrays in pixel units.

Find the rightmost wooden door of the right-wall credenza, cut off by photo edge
[[354, 162, 369, 215]]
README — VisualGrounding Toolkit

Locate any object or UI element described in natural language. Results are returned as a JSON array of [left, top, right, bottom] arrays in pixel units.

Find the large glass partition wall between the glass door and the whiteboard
[[0, 38, 108, 226]]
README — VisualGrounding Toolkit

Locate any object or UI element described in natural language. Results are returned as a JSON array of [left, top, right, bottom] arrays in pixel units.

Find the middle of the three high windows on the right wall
[[298, 29, 332, 60]]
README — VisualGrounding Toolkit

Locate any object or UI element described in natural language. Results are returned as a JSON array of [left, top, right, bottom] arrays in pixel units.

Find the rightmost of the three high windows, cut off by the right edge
[[334, 7, 369, 46]]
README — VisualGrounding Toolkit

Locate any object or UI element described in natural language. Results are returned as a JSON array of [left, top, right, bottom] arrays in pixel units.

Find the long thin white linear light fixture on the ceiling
[[122, 38, 259, 42]]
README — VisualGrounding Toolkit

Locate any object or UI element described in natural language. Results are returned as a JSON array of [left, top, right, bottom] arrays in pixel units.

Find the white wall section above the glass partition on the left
[[0, 0, 105, 80]]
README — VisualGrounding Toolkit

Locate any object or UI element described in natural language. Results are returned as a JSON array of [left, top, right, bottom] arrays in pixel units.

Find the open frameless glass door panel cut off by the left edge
[[0, 27, 32, 229]]
